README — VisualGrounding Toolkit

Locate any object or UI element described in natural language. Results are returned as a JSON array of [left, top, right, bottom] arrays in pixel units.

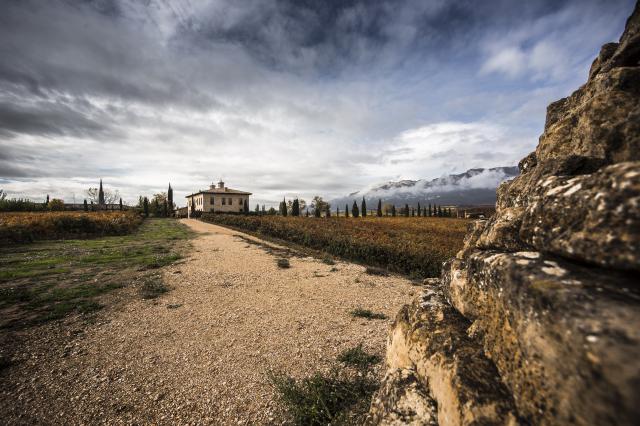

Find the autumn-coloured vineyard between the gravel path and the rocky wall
[[202, 214, 468, 277]]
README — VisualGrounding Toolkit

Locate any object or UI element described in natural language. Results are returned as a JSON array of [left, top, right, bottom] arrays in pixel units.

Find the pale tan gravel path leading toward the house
[[0, 220, 417, 424]]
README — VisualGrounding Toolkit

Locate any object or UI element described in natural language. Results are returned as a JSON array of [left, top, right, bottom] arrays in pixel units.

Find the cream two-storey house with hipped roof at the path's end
[[186, 181, 251, 217]]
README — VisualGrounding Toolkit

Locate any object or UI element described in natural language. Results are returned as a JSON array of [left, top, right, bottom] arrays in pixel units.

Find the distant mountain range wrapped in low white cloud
[[331, 166, 519, 208]]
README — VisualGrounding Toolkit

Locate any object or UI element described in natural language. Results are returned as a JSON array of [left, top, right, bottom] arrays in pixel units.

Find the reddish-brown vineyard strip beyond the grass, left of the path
[[0, 211, 142, 243]]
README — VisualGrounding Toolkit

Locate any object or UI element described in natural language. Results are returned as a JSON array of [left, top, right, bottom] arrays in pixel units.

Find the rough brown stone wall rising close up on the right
[[369, 5, 640, 425]]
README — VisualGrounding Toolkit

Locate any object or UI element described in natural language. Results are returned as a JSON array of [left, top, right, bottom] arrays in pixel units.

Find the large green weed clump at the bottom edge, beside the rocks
[[270, 369, 378, 426]]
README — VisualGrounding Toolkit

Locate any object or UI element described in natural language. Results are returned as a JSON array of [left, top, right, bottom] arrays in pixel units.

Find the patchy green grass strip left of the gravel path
[[0, 219, 193, 327]]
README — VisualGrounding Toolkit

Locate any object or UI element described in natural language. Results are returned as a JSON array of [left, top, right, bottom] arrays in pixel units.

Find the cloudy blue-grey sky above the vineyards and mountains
[[0, 0, 634, 206]]
